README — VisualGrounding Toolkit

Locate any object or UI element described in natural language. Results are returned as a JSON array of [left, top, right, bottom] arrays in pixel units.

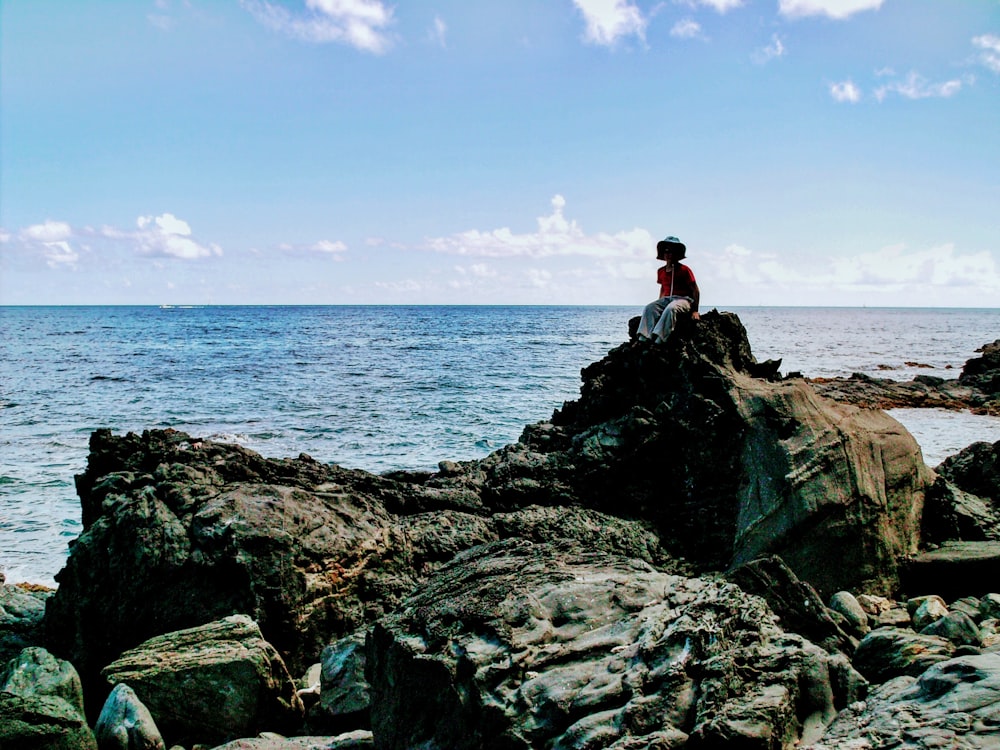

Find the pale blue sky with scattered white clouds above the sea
[[0, 0, 1000, 310]]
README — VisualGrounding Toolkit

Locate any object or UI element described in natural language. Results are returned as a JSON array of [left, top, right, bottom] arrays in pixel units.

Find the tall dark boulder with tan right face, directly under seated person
[[458, 311, 933, 595]]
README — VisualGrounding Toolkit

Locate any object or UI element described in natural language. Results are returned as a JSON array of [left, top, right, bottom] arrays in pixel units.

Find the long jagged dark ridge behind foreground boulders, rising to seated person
[[37, 311, 933, 742]]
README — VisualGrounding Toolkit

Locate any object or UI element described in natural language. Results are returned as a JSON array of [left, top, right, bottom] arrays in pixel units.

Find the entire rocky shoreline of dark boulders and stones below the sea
[[0, 311, 1000, 750]]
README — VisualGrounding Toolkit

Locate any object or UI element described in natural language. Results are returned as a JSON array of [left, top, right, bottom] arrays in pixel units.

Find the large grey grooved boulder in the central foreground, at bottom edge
[[368, 542, 856, 750]]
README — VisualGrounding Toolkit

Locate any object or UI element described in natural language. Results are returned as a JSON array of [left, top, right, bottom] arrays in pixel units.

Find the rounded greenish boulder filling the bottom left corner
[[0, 647, 97, 750]]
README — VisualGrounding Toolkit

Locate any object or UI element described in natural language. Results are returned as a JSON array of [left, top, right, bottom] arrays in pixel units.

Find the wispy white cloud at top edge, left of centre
[[240, 0, 393, 54]]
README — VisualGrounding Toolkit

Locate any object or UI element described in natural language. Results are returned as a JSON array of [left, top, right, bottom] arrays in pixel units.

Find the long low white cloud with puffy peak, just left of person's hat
[[425, 195, 656, 258]]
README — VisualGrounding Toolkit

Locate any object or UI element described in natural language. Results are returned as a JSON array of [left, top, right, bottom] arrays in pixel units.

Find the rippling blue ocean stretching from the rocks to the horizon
[[0, 306, 1000, 586]]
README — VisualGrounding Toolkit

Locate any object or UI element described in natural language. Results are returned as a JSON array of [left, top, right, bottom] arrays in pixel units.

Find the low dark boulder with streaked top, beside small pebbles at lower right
[[852, 627, 955, 683]]
